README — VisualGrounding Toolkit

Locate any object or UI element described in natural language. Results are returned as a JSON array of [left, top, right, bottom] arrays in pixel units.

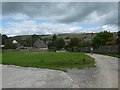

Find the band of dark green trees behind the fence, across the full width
[[2, 31, 120, 50]]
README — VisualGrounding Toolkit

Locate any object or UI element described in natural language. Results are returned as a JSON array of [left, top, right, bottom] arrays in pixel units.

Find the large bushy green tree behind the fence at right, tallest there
[[92, 31, 113, 47]]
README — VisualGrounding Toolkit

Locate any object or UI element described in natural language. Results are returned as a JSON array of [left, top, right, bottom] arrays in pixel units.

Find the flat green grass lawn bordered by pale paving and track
[[2, 52, 95, 70]]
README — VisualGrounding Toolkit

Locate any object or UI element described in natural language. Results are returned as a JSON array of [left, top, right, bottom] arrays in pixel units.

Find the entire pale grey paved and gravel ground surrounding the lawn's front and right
[[2, 54, 118, 88]]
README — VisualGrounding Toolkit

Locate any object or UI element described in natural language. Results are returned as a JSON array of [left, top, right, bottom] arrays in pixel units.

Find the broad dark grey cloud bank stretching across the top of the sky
[[2, 2, 118, 24]]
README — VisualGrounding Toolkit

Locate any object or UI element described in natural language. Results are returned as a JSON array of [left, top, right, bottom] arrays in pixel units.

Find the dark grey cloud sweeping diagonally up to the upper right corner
[[60, 3, 118, 24]]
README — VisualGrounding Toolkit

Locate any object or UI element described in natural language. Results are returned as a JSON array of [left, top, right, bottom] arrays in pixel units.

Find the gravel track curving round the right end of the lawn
[[68, 54, 118, 88]]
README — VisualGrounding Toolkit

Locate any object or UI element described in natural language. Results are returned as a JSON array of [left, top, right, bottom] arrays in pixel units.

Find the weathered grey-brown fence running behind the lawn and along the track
[[4, 45, 120, 53]]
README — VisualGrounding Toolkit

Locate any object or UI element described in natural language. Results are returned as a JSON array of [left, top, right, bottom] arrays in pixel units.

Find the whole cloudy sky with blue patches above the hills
[[1, 2, 118, 36]]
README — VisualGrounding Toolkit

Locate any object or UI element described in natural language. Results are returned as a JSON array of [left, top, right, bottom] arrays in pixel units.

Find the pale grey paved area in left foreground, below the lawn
[[2, 65, 76, 88]]
